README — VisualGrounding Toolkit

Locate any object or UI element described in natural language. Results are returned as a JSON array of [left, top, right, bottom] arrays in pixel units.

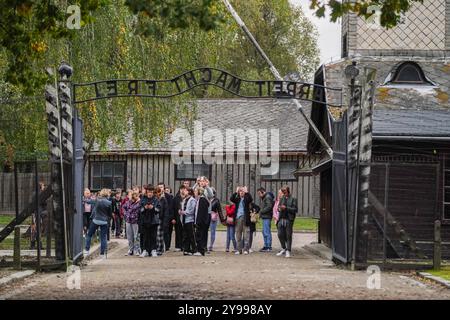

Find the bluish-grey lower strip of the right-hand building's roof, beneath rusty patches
[[373, 109, 450, 137]]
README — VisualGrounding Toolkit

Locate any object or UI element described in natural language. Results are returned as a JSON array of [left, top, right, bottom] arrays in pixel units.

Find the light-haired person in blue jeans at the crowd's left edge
[[84, 189, 112, 259]]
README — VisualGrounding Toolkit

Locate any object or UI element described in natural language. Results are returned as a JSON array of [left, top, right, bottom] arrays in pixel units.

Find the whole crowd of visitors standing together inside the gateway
[[84, 177, 297, 257]]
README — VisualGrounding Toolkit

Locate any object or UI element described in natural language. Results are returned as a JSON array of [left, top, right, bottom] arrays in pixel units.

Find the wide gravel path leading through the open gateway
[[0, 232, 450, 299]]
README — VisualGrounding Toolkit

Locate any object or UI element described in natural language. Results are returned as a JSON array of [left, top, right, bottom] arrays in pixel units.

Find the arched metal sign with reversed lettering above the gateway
[[73, 68, 342, 107]]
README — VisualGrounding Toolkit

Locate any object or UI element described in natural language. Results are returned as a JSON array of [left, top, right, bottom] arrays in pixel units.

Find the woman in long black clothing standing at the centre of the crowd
[[194, 187, 211, 256]]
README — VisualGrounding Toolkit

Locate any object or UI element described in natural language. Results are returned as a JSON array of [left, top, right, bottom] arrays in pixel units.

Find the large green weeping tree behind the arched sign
[[0, 0, 319, 168]]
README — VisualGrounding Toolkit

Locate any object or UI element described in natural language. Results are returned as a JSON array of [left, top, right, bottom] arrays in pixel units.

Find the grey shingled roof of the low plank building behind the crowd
[[94, 99, 311, 152]]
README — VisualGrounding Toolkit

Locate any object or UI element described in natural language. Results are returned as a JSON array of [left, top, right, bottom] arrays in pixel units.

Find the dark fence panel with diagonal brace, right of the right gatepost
[[358, 157, 439, 264]]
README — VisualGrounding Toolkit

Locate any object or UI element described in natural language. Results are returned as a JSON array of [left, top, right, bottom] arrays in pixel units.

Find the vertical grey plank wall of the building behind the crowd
[[85, 154, 320, 217]]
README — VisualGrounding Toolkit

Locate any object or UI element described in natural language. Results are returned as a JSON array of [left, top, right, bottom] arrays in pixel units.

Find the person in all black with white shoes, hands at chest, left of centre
[[141, 187, 161, 258]]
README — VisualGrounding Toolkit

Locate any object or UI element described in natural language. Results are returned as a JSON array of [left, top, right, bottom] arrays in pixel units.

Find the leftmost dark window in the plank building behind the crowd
[[90, 161, 125, 191]]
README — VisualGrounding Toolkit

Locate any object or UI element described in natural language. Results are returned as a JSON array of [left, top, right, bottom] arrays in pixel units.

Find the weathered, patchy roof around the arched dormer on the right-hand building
[[316, 56, 450, 137]]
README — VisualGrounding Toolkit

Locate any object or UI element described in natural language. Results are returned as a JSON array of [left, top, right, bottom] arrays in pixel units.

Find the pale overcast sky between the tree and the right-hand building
[[289, 0, 341, 63]]
